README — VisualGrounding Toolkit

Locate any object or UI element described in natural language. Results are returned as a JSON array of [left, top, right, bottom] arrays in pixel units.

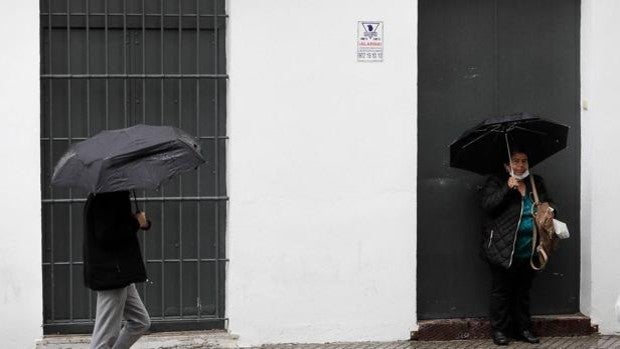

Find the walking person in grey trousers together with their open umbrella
[[52, 125, 205, 349]]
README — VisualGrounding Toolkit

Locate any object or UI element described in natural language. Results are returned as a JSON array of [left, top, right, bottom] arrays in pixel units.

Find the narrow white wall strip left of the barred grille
[[0, 1, 43, 348]]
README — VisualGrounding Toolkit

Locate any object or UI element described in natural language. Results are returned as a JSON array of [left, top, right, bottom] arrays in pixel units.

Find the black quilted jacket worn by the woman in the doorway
[[482, 174, 551, 269]]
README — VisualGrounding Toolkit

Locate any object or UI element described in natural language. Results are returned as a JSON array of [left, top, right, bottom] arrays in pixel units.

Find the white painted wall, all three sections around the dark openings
[[7, 0, 620, 348]]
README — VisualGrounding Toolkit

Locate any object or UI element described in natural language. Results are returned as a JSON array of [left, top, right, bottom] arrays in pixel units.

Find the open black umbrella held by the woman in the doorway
[[450, 113, 568, 174]]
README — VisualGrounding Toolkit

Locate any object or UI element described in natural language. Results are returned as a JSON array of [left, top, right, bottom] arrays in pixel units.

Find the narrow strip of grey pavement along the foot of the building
[[37, 331, 620, 349]]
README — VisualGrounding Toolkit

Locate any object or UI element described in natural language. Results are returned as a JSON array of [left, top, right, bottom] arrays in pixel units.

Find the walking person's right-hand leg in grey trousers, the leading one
[[113, 284, 151, 349]]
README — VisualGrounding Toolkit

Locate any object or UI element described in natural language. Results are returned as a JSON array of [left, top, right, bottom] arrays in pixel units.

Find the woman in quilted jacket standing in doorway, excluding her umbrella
[[482, 148, 550, 345]]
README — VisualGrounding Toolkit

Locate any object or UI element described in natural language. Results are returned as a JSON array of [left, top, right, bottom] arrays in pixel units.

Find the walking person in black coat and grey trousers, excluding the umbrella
[[83, 191, 151, 349]]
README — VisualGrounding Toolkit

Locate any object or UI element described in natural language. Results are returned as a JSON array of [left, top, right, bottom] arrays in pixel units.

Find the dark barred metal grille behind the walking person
[[40, 0, 228, 333]]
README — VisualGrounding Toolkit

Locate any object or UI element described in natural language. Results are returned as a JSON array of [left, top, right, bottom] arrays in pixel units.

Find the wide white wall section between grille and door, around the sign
[[226, 0, 417, 345]]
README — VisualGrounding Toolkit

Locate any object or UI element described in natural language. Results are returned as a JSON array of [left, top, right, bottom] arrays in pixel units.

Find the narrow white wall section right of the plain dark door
[[581, 0, 620, 334]]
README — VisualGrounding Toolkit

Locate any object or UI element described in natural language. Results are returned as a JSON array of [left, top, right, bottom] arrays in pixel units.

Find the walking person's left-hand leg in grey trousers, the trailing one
[[90, 288, 127, 349]]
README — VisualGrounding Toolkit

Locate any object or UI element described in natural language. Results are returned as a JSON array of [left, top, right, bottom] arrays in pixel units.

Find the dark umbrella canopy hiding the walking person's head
[[52, 125, 205, 193]]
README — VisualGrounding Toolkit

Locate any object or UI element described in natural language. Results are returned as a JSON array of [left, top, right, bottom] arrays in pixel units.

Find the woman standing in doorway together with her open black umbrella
[[450, 113, 568, 345]]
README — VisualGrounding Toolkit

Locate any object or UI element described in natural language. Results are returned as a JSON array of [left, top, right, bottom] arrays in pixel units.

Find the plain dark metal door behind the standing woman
[[417, 0, 580, 320]]
